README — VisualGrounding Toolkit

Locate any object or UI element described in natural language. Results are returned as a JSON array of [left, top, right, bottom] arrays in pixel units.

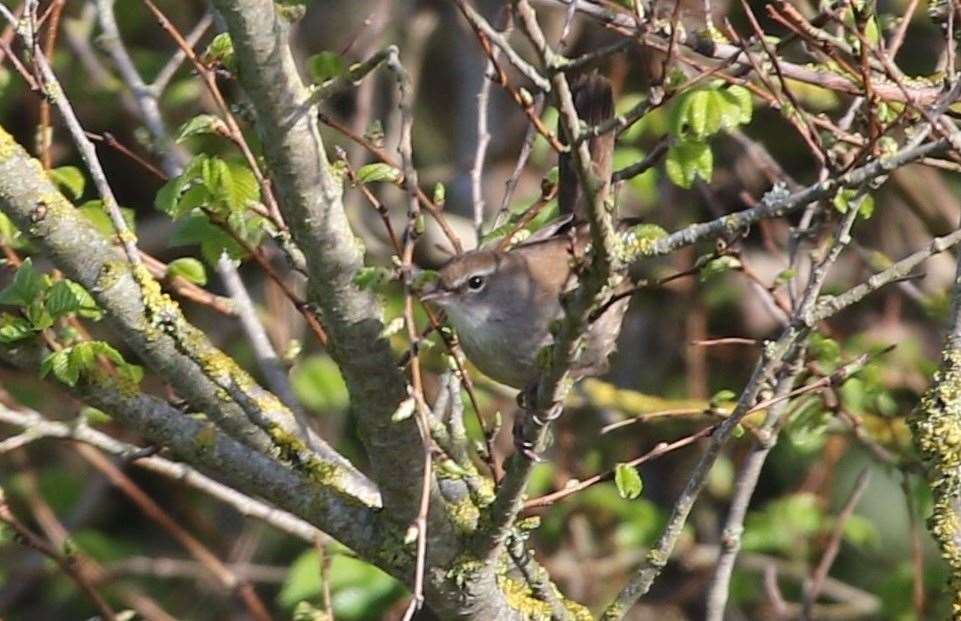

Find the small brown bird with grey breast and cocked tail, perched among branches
[[421, 75, 628, 389]]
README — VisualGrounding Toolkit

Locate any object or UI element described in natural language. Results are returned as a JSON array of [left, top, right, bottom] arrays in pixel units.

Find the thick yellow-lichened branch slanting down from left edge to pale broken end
[[0, 123, 377, 504]]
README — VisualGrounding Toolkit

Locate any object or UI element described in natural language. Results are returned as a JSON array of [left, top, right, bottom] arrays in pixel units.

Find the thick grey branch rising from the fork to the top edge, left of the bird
[[214, 0, 423, 522]]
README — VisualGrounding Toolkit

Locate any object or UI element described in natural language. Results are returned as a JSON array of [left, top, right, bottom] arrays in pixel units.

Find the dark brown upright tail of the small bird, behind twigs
[[557, 74, 615, 222]]
